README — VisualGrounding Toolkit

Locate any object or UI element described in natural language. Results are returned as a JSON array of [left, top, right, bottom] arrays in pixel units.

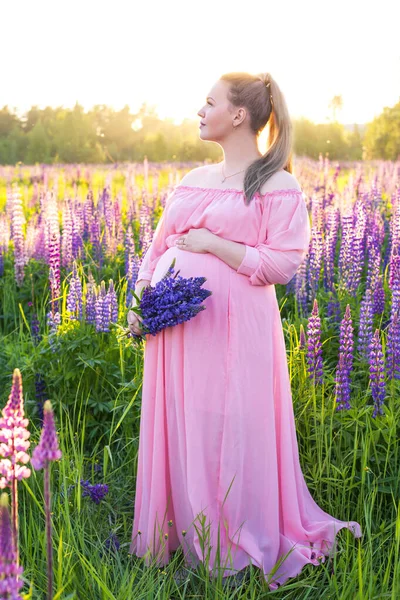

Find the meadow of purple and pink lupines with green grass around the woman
[[0, 158, 400, 600]]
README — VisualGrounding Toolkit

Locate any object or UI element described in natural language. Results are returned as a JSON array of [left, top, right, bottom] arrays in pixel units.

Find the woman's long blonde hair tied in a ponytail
[[220, 72, 293, 205]]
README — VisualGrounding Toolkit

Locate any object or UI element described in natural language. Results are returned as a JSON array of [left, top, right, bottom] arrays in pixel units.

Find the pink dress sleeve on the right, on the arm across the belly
[[237, 190, 311, 285]]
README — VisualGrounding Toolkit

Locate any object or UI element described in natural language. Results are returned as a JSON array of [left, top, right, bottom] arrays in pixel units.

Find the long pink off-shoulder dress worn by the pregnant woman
[[130, 185, 362, 589]]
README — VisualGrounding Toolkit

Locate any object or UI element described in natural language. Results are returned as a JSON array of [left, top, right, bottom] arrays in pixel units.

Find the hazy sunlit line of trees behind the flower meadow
[[0, 102, 400, 165]]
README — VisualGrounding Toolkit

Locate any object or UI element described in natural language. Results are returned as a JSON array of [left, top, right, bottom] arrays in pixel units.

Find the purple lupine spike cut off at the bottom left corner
[[0, 492, 24, 600]]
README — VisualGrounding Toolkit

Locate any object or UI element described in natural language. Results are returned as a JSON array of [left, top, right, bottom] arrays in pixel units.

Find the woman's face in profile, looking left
[[197, 80, 244, 141]]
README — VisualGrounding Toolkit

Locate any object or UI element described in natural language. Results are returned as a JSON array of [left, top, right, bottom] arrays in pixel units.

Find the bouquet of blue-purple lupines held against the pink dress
[[119, 258, 212, 339]]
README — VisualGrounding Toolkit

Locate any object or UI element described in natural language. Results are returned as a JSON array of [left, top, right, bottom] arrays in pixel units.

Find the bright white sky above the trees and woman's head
[[0, 0, 400, 124]]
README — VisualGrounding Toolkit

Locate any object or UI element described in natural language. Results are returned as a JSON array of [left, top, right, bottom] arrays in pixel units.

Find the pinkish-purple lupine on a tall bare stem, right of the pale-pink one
[[31, 400, 61, 600]]
